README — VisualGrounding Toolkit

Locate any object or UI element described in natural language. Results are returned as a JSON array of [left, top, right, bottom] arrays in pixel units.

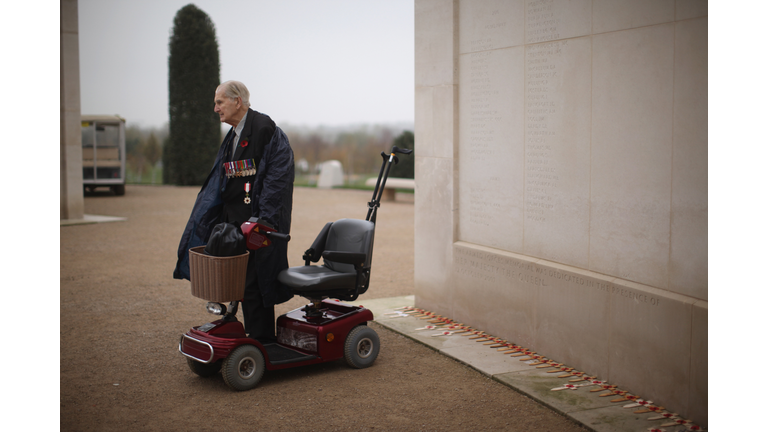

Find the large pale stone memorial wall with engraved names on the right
[[415, 0, 708, 424]]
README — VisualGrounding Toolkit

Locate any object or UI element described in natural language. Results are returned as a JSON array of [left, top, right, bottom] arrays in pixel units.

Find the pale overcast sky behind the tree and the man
[[78, 0, 414, 126]]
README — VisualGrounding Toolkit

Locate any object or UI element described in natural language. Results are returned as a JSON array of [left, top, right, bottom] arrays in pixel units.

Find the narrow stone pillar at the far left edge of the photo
[[59, 0, 83, 219]]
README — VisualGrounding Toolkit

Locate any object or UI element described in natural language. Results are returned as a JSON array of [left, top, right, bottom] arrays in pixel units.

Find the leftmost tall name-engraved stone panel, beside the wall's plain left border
[[459, 46, 524, 251]]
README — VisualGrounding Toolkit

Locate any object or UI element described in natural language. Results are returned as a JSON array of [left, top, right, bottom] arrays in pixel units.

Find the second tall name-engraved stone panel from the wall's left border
[[524, 38, 591, 267]]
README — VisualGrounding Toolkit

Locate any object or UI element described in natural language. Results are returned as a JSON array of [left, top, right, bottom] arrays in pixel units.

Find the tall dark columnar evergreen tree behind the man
[[163, 4, 221, 185]]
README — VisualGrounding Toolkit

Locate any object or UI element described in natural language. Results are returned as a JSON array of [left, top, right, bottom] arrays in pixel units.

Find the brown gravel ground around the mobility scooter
[[59, 186, 584, 431]]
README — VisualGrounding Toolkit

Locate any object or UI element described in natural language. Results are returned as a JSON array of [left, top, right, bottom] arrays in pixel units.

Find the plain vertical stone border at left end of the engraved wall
[[414, 0, 459, 314]]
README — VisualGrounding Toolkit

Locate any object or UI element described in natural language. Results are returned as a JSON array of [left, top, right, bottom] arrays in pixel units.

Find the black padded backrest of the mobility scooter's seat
[[323, 219, 375, 273]]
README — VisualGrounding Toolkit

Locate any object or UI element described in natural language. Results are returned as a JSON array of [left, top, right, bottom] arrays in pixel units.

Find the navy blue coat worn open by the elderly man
[[173, 109, 295, 306]]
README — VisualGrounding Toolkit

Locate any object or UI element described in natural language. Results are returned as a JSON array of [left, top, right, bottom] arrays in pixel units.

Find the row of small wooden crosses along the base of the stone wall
[[385, 306, 702, 432]]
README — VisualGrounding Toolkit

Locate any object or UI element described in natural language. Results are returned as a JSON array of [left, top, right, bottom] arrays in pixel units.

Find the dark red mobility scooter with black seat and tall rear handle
[[179, 147, 413, 391]]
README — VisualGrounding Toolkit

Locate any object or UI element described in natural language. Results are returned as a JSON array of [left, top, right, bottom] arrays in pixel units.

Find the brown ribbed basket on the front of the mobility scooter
[[189, 246, 249, 302]]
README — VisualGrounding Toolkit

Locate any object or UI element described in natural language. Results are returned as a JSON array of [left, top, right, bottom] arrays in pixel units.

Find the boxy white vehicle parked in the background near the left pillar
[[80, 115, 125, 195]]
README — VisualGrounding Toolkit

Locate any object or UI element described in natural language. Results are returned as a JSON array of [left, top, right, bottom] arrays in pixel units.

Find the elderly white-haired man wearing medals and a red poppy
[[173, 81, 294, 342]]
